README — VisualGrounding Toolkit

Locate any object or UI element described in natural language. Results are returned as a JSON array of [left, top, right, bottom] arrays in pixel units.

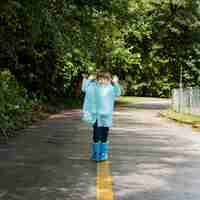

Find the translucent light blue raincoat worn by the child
[[82, 79, 121, 127]]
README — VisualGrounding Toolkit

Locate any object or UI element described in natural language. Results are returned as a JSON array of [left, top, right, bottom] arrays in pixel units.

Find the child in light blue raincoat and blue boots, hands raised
[[82, 72, 121, 161]]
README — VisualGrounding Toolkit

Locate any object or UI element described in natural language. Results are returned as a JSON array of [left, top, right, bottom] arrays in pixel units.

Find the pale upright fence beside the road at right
[[172, 87, 200, 116]]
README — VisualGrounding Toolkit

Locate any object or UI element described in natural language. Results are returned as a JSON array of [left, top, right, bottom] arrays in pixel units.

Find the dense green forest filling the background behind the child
[[0, 0, 200, 137]]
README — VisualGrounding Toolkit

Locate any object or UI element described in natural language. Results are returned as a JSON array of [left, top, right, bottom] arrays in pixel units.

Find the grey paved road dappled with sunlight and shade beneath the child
[[0, 102, 200, 200]]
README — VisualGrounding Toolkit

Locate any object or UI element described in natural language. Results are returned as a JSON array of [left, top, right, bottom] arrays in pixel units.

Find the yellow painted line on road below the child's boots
[[96, 161, 113, 200]]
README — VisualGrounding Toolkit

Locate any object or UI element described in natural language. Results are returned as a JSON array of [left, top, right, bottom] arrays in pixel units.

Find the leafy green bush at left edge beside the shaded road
[[0, 70, 34, 141]]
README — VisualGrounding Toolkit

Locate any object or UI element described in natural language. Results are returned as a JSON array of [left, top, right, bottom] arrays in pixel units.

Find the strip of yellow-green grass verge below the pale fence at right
[[160, 109, 200, 131]]
